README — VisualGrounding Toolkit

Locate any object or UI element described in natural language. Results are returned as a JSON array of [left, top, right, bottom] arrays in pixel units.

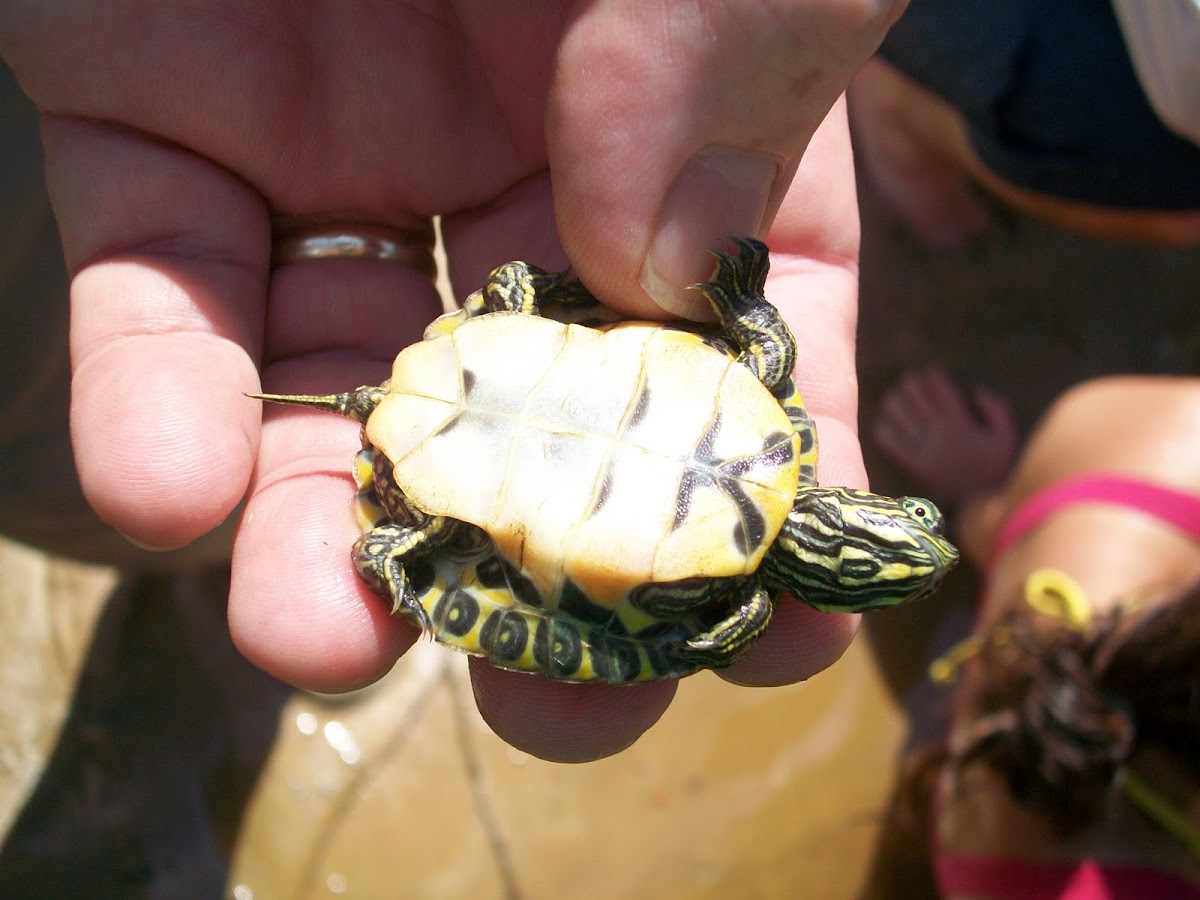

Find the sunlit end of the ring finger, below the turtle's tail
[[229, 427, 419, 692]]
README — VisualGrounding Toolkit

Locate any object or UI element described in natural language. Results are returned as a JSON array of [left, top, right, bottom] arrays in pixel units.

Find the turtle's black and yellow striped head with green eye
[[760, 487, 959, 612]]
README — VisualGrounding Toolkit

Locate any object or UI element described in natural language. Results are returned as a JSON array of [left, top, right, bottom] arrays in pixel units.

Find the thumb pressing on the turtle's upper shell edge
[[547, 0, 904, 317]]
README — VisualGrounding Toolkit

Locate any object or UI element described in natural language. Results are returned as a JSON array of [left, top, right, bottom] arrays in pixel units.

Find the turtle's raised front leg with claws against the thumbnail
[[692, 238, 796, 390]]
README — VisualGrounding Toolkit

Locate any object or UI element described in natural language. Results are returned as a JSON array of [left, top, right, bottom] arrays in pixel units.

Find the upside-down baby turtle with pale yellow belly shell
[[251, 239, 958, 683]]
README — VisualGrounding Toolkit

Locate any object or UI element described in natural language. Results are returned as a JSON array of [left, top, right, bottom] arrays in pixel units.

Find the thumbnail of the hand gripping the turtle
[[641, 146, 779, 318]]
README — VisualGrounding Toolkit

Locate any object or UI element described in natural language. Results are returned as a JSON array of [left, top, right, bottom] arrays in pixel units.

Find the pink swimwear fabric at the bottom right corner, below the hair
[[934, 854, 1200, 900]]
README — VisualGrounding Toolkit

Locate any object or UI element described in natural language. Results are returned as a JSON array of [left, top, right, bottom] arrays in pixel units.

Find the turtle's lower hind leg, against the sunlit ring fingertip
[[350, 516, 458, 629]]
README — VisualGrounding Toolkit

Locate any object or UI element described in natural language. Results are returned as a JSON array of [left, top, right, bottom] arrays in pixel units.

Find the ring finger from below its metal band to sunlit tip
[[229, 254, 440, 691]]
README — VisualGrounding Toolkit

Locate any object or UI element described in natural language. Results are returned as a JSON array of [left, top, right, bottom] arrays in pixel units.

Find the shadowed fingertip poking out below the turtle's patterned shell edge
[[470, 659, 678, 762]]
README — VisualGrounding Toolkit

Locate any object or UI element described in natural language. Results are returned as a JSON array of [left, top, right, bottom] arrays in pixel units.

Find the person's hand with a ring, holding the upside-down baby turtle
[[0, 0, 899, 760]]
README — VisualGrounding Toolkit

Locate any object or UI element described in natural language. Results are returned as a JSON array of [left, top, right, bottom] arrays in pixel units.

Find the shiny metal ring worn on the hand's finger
[[271, 223, 436, 276]]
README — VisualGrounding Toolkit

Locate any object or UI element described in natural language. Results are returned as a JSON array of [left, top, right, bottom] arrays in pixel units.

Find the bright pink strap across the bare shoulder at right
[[991, 475, 1200, 560]]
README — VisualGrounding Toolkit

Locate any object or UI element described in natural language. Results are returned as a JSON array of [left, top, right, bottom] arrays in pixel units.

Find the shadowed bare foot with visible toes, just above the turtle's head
[[872, 366, 1018, 504]]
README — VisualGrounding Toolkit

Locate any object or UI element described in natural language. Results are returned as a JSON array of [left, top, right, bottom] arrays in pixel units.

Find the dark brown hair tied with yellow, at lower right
[[946, 583, 1200, 834]]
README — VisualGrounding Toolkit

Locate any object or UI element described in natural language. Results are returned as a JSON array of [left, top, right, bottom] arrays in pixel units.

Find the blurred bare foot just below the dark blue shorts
[[847, 59, 995, 250]]
